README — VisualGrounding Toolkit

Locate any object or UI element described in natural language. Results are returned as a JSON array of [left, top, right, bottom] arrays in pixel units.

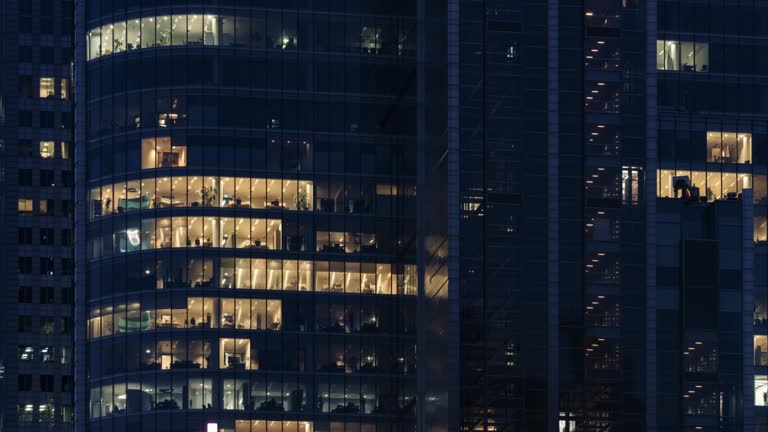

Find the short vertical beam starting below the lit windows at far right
[[741, 189, 755, 432]]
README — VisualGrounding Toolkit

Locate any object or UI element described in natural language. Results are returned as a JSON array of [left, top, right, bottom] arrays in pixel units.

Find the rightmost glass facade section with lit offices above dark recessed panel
[[656, 0, 768, 432]]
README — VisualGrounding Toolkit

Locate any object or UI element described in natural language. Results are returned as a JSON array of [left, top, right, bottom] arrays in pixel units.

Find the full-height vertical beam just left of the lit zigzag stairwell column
[[547, 0, 560, 432]]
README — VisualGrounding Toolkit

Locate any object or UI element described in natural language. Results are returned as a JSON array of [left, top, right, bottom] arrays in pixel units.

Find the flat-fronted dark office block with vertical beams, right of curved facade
[[448, 0, 768, 431]]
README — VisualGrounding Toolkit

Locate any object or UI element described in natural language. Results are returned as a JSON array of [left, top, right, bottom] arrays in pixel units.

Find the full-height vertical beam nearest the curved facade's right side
[[446, 0, 462, 431]]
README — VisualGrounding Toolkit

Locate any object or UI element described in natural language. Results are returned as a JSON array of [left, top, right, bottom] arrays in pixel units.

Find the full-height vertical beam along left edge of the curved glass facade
[[74, 0, 89, 432]]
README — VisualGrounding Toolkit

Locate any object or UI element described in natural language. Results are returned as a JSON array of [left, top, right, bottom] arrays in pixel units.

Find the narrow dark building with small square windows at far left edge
[[0, 0, 74, 431]]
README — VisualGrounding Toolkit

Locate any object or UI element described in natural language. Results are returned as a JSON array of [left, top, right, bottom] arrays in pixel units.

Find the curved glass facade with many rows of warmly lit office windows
[[78, 1, 417, 432]]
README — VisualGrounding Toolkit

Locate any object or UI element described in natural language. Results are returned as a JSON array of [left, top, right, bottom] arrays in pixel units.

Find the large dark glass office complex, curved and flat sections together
[[75, 0, 768, 432]]
